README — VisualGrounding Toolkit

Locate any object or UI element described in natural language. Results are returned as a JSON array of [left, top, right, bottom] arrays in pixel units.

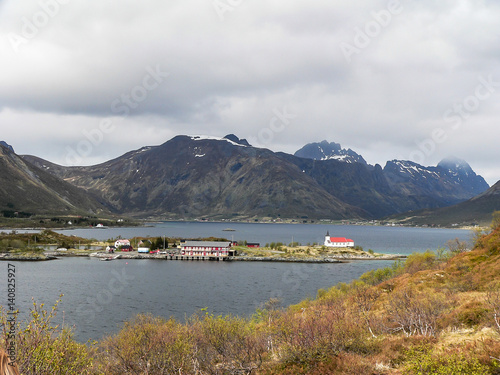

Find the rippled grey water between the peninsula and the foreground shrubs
[[0, 258, 392, 341]]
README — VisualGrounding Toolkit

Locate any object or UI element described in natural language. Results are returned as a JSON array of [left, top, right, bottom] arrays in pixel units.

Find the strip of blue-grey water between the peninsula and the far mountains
[[59, 222, 470, 254]]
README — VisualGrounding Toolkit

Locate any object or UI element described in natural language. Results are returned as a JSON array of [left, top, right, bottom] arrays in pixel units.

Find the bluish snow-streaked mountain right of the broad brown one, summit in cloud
[[282, 154, 488, 218]]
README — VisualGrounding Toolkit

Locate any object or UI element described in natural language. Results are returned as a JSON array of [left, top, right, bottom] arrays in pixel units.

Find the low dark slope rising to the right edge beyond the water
[[393, 181, 500, 225]]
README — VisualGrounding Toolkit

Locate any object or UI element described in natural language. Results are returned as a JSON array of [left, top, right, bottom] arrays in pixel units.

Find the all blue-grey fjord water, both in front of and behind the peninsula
[[0, 223, 469, 341]]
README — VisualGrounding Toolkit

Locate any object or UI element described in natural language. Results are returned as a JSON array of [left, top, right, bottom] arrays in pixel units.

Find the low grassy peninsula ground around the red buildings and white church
[[0, 229, 401, 262]]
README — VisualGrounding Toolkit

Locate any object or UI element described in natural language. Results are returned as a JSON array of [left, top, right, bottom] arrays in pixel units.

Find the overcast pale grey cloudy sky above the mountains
[[0, 0, 500, 184]]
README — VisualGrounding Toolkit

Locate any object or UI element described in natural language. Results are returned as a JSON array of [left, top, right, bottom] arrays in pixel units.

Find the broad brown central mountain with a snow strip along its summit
[[23, 136, 367, 219]]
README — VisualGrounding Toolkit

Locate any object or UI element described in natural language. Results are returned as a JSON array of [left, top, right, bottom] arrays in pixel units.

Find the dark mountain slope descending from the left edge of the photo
[[0, 145, 108, 214]]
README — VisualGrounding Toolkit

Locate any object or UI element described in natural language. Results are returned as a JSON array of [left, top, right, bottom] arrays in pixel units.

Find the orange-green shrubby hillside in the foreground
[[0, 227, 500, 375]]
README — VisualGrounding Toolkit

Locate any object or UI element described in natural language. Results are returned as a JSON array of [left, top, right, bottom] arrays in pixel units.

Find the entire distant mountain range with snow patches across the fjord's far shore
[[10, 134, 489, 223]]
